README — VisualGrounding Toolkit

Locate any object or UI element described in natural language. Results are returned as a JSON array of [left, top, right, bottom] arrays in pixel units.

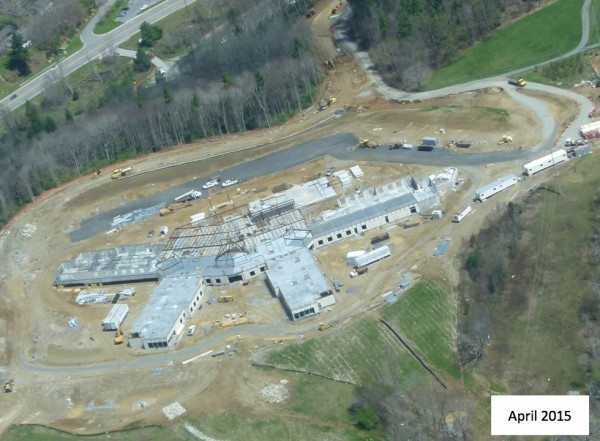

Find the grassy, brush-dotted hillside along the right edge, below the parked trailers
[[460, 154, 600, 394]]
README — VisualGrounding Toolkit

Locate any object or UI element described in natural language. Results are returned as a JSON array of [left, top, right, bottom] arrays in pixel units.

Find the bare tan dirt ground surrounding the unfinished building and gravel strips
[[0, 2, 575, 433]]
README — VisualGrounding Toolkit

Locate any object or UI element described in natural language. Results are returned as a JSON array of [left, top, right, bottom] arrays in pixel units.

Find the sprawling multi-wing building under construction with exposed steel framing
[[55, 169, 456, 342]]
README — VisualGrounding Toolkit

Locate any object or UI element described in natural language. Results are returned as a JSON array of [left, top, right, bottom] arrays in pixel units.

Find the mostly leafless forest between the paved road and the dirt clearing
[[0, 0, 322, 223]]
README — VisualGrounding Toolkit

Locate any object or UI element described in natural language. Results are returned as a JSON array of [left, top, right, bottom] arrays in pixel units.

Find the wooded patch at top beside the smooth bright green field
[[348, 0, 540, 90]]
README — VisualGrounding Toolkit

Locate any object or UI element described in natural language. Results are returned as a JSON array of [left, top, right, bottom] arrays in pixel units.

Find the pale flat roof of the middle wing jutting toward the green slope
[[266, 248, 331, 311]]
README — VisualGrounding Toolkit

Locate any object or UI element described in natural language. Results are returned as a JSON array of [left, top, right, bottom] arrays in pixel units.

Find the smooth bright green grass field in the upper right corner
[[422, 0, 583, 90]]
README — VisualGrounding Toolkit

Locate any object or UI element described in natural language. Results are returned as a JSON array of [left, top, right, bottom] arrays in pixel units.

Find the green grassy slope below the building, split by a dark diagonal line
[[266, 280, 458, 384]]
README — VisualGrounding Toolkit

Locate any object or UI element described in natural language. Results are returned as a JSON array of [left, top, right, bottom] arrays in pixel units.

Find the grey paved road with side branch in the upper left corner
[[0, 0, 196, 110]]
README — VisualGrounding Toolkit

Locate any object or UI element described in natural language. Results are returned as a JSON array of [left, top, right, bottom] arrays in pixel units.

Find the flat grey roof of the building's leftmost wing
[[54, 244, 164, 286]]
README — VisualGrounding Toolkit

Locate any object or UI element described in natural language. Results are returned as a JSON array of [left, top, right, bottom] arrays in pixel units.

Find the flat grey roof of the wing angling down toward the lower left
[[131, 275, 202, 340]]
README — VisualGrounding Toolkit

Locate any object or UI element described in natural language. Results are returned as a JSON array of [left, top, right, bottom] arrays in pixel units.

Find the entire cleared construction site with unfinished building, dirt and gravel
[[0, 2, 597, 434]]
